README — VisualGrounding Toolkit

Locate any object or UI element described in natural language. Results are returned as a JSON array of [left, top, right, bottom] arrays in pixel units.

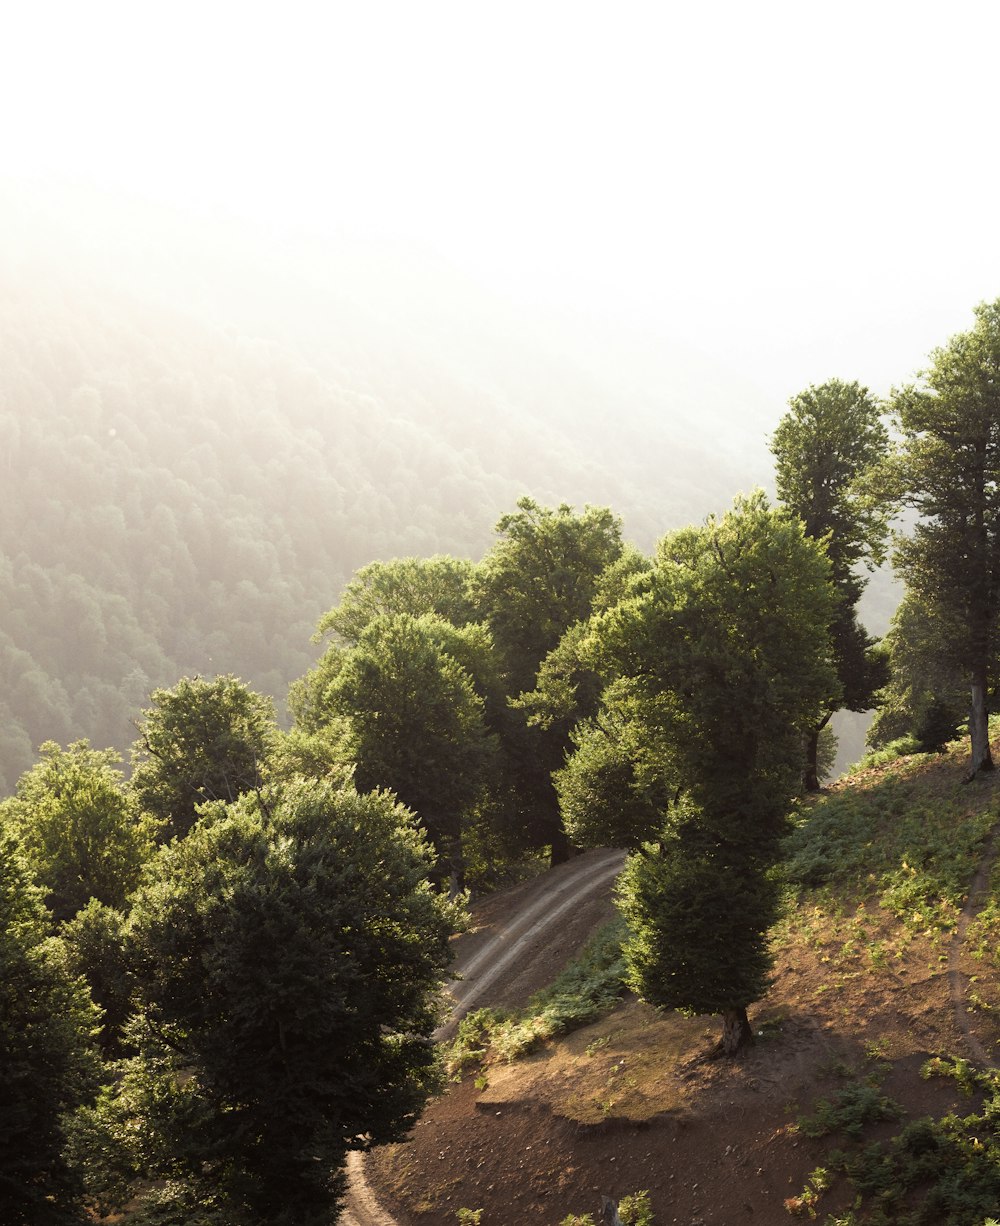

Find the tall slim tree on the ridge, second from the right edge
[[771, 379, 888, 792]]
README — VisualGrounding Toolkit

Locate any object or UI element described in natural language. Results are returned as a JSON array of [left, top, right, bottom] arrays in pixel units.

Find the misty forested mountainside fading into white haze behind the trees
[[0, 191, 778, 792]]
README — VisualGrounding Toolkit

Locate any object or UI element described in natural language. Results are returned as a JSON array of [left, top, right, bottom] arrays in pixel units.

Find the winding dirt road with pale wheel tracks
[[339, 851, 625, 1226]]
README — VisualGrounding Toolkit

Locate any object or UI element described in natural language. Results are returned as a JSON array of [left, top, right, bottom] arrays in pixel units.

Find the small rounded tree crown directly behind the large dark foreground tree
[[132, 676, 277, 836]]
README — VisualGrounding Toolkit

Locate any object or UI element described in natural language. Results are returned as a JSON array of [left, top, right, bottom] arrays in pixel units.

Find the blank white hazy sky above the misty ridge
[[0, 0, 1000, 402]]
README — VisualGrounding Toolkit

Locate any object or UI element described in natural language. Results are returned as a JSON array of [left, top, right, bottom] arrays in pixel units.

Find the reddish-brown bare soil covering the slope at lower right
[[366, 779, 1000, 1226]]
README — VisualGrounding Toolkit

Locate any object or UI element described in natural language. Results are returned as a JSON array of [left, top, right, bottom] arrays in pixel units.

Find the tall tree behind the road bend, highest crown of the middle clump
[[469, 498, 624, 862]]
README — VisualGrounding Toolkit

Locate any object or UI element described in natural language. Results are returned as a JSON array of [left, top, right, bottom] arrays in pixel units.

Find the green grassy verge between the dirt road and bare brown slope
[[445, 918, 625, 1078]]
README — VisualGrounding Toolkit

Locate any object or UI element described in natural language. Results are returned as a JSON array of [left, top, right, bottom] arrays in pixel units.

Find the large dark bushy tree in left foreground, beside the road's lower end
[[76, 780, 456, 1226]]
